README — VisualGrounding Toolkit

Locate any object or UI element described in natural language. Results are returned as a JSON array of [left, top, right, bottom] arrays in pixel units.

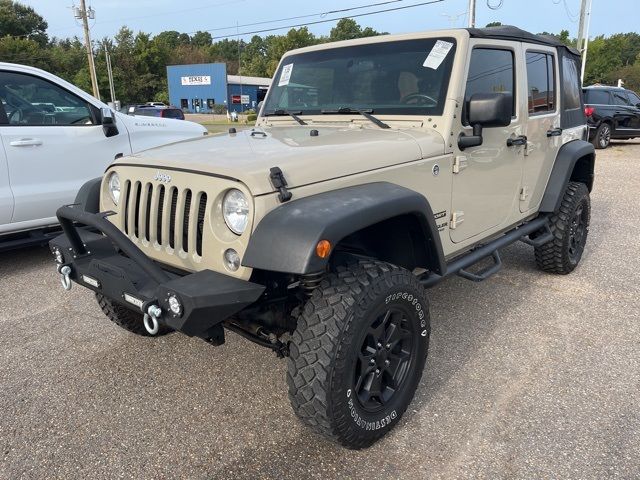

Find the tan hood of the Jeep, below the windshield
[[116, 125, 444, 195]]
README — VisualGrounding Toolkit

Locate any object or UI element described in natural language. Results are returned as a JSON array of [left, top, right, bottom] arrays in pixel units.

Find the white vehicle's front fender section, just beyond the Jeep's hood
[[116, 112, 207, 153]]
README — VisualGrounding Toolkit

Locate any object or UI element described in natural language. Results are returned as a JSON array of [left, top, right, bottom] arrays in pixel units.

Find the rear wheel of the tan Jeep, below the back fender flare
[[535, 182, 591, 275]]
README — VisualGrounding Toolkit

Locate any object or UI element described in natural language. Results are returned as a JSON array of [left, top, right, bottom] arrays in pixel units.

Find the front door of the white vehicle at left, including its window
[[0, 71, 131, 223]]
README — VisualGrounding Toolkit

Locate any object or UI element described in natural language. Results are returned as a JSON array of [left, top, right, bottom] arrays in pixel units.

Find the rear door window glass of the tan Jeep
[[526, 52, 556, 115]]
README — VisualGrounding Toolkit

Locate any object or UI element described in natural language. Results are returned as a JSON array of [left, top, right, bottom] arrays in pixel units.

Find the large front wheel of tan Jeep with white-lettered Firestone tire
[[287, 260, 430, 449]]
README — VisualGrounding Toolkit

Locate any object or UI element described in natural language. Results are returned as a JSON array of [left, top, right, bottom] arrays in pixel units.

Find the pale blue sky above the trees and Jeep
[[19, 0, 640, 39]]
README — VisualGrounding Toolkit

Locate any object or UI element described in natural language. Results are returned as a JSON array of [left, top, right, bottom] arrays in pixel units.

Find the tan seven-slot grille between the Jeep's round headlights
[[121, 180, 207, 256]]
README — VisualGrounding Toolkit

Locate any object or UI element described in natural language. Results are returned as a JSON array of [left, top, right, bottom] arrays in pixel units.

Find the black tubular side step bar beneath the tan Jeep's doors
[[420, 216, 553, 288]]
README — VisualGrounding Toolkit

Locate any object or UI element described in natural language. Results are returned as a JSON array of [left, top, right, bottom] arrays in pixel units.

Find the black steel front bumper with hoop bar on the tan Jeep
[[49, 206, 264, 339]]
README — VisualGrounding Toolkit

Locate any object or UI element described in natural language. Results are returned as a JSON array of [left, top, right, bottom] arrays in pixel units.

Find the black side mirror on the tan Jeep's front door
[[458, 93, 513, 150]]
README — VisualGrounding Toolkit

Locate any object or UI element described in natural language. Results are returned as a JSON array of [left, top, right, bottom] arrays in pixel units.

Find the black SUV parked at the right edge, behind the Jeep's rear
[[582, 87, 640, 148]]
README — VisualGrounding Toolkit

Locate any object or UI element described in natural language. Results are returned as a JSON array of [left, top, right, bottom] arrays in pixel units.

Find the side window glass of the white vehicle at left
[[0, 72, 94, 126]]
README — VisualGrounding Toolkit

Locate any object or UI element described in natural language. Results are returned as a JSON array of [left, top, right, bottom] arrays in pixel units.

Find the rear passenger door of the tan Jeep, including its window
[[520, 44, 562, 213]]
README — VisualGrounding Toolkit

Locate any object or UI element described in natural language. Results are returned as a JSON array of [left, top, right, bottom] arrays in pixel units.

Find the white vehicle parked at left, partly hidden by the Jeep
[[0, 62, 207, 250]]
